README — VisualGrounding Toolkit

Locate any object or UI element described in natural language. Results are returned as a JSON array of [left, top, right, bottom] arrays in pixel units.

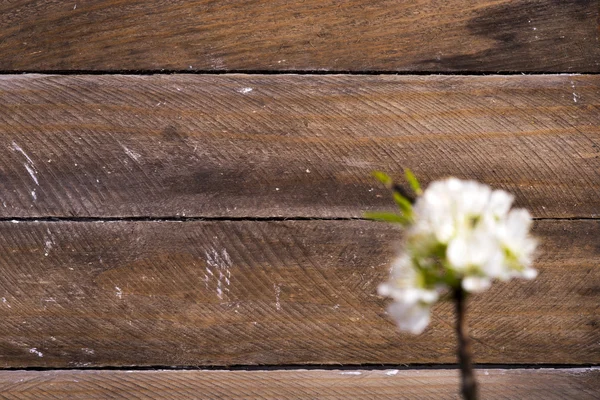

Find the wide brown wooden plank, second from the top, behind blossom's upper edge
[[0, 75, 600, 217]]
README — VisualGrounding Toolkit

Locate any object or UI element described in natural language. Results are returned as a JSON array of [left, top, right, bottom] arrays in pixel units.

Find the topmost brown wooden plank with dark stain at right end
[[0, 0, 600, 72]]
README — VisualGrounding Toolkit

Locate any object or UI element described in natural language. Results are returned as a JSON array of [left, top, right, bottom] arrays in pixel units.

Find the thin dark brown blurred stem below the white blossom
[[454, 286, 477, 400]]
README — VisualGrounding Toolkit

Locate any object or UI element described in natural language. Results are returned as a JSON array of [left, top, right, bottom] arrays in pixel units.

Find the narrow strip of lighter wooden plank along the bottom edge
[[0, 368, 600, 400]]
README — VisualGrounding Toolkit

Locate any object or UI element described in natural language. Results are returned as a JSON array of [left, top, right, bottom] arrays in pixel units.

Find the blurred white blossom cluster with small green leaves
[[374, 172, 537, 334]]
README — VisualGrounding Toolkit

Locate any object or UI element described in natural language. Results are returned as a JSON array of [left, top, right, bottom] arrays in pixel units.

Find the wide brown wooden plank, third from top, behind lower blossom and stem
[[0, 220, 600, 368]]
